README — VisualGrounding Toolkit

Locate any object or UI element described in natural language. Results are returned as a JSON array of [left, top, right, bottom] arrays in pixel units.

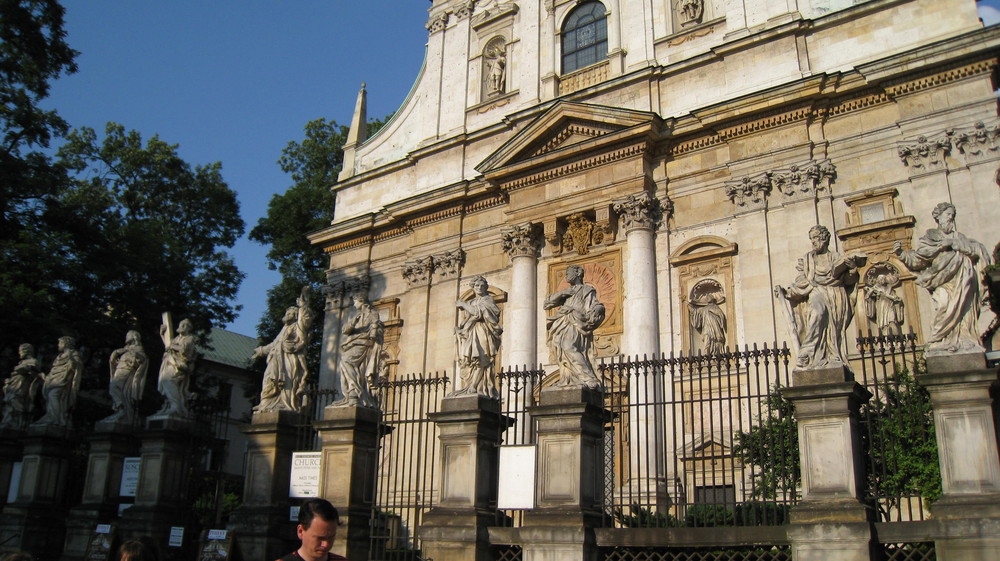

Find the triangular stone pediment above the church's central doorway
[[476, 101, 663, 174]]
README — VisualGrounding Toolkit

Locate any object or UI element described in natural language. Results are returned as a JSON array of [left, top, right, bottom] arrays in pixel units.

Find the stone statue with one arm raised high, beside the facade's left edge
[[251, 286, 313, 412]]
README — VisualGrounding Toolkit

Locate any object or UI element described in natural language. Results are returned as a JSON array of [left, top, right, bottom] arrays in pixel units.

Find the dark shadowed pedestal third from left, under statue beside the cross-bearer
[[62, 423, 139, 561]]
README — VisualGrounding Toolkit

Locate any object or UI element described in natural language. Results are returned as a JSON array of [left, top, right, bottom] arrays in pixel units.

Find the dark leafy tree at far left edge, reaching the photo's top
[[0, 0, 77, 354]]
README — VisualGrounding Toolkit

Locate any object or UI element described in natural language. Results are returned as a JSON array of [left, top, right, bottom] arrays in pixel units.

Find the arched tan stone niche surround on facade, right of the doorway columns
[[670, 236, 739, 354]]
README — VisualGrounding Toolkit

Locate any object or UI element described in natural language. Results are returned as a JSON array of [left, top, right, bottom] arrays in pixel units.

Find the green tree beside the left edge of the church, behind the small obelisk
[[250, 117, 390, 373]]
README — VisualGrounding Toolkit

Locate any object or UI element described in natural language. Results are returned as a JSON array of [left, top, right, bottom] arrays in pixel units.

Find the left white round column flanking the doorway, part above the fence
[[500, 223, 541, 368]]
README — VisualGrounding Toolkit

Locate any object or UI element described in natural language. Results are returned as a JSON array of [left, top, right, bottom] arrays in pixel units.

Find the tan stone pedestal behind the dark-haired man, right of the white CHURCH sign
[[313, 406, 384, 561]]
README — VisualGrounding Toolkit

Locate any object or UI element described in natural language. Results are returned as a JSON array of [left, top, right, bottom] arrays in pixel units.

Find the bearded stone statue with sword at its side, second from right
[[774, 226, 867, 370]]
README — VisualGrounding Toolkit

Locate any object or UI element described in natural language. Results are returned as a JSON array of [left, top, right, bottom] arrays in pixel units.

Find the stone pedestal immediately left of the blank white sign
[[420, 395, 513, 561]]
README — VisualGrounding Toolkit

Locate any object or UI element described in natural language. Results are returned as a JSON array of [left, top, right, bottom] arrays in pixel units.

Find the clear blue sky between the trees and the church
[[45, 0, 1000, 336]]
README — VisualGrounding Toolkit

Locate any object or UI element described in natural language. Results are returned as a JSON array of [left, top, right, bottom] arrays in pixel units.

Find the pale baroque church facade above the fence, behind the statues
[[310, 0, 1000, 388]]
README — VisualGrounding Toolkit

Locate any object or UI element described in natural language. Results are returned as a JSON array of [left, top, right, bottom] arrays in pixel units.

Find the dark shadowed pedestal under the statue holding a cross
[[120, 419, 204, 548]]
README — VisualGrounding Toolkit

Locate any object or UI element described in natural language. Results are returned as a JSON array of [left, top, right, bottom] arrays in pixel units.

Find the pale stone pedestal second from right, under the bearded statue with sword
[[781, 366, 874, 561]]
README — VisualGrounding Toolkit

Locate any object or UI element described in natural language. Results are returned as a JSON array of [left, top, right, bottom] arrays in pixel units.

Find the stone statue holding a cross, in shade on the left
[[156, 319, 198, 419]]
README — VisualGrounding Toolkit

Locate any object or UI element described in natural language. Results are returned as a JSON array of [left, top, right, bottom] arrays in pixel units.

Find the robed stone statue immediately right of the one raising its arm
[[334, 294, 385, 407]]
